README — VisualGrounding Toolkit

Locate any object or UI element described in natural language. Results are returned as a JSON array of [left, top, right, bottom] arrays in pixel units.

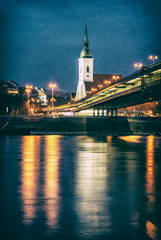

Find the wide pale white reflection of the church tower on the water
[[76, 137, 111, 237]]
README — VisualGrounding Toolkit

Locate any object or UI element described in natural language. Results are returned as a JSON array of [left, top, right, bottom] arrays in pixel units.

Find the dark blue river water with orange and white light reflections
[[0, 136, 161, 240]]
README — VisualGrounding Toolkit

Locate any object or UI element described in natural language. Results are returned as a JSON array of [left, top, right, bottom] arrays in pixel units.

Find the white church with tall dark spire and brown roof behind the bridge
[[76, 25, 122, 101]]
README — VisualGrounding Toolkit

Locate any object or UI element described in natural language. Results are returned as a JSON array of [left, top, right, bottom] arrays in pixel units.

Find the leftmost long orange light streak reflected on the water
[[20, 136, 40, 223]]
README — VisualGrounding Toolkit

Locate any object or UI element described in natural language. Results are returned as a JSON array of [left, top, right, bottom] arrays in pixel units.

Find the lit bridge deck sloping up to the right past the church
[[43, 61, 161, 112]]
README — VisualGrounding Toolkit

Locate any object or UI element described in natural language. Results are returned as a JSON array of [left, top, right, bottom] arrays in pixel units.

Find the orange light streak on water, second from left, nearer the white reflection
[[44, 136, 61, 228]]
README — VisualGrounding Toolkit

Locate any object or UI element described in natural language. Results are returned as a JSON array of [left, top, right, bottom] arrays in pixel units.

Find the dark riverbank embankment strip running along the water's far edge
[[0, 116, 161, 135]]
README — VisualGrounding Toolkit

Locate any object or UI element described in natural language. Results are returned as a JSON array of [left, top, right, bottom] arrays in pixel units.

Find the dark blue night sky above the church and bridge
[[0, 0, 161, 91]]
